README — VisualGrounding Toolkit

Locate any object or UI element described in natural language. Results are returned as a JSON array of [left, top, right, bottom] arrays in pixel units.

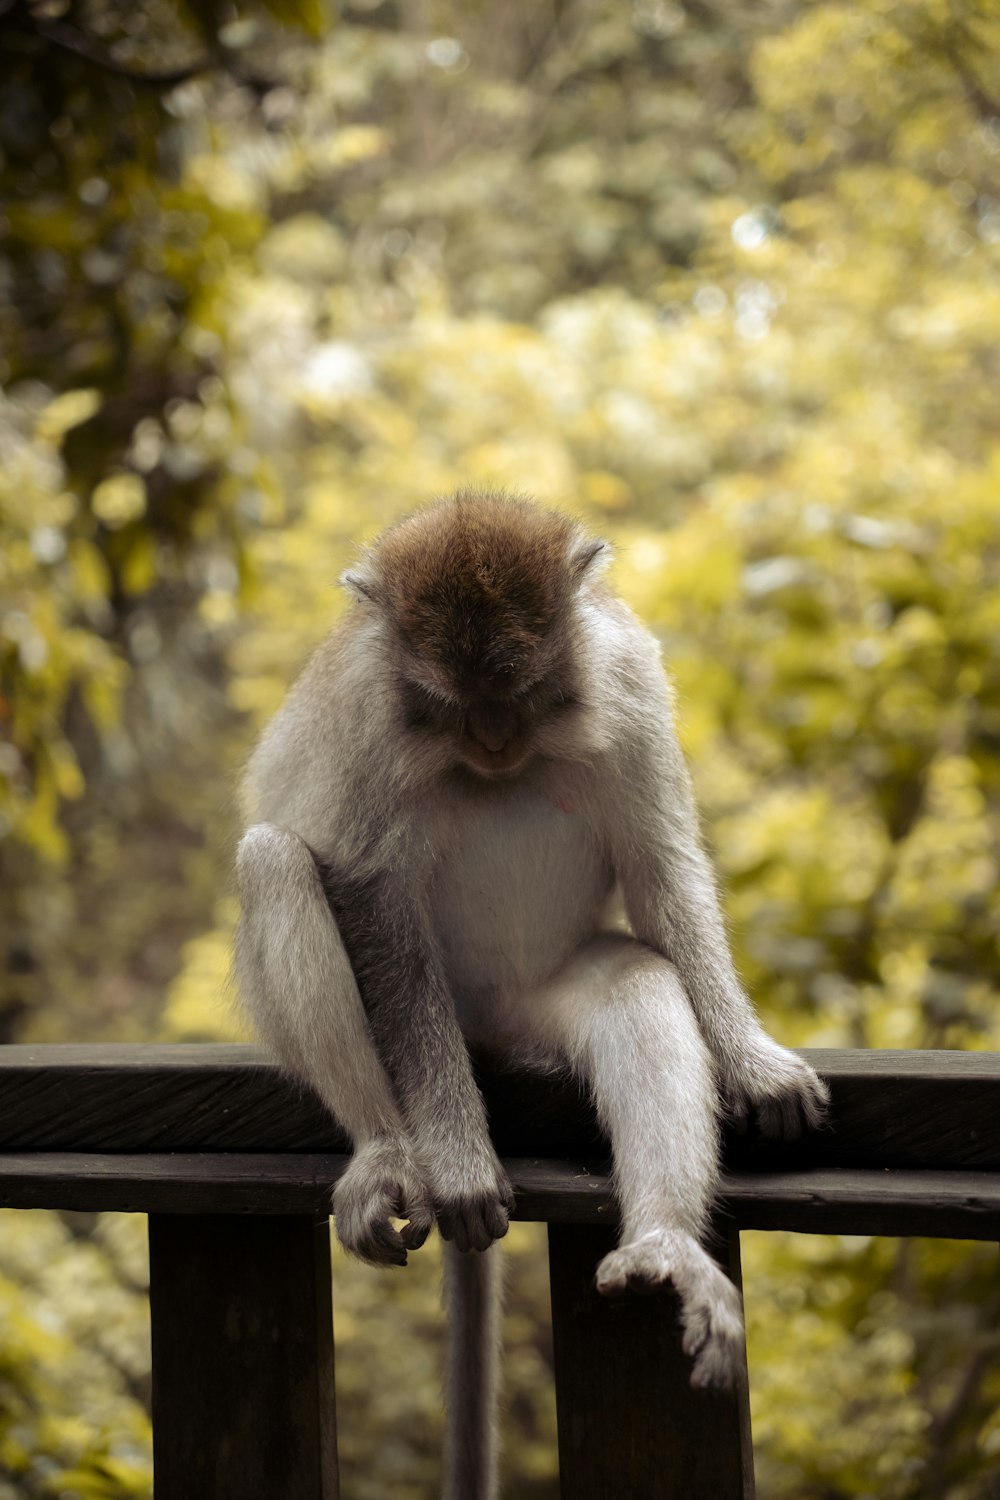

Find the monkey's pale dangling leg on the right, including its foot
[[515, 935, 744, 1386]]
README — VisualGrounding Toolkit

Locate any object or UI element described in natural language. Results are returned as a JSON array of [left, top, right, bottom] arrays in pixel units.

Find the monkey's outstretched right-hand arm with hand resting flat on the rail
[[610, 678, 828, 1137]]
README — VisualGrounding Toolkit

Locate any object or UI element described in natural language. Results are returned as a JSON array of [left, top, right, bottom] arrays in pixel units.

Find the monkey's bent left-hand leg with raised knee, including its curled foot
[[235, 824, 433, 1266]]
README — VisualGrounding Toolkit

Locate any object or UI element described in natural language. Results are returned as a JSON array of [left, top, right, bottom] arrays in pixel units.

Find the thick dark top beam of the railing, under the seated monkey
[[0, 1044, 1000, 1172]]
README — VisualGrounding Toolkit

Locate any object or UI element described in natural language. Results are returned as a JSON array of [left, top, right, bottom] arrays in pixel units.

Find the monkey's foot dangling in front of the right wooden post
[[597, 1229, 745, 1391]]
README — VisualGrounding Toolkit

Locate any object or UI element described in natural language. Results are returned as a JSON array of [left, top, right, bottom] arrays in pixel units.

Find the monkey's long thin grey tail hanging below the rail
[[442, 1244, 504, 1500]]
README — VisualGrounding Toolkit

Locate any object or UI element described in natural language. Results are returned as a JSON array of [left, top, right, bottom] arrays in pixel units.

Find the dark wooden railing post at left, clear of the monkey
[[150, 1214, 339, 1500]]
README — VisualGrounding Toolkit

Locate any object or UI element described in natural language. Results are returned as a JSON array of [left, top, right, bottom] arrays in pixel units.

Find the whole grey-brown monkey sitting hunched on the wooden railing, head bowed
[[235, 489, 826, 1500]]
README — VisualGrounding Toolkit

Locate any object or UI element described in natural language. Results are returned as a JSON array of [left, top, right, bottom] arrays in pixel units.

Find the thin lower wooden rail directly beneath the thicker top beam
[[0, 1152, 1000, 1241]]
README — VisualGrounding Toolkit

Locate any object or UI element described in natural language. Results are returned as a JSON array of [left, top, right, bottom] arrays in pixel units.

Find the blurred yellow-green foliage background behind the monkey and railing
[[0, 0, 1000, 1500]]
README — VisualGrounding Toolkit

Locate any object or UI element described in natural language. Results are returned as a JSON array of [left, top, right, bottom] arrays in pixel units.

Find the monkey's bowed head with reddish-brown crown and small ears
[[342, 491, 607, 779]]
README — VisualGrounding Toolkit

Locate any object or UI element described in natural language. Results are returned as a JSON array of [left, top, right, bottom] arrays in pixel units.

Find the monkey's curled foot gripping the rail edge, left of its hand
[[333, 1136, 433, 1266]]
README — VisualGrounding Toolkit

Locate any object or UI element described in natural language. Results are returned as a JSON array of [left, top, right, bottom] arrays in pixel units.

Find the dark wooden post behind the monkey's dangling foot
[[549, 1224, 754, 1500]]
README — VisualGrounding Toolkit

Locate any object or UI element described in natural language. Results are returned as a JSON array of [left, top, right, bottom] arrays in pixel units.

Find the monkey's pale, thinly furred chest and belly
[[430, 794, 612, 995]]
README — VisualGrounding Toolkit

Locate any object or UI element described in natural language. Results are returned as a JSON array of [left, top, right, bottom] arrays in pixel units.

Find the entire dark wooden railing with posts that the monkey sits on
[[0, 1046, 1000, 1500]]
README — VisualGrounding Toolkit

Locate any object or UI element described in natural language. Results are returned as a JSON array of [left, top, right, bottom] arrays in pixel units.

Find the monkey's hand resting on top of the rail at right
[[715, 1029, 829, 1140]]
